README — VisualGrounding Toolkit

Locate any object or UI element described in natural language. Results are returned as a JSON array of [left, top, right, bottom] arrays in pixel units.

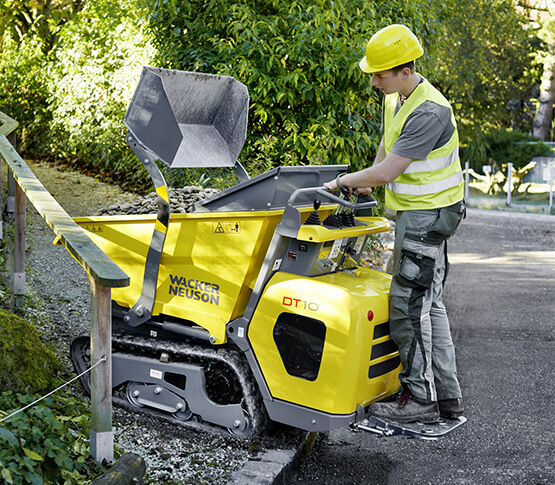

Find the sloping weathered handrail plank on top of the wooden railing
[[0, 135, 129, 288]]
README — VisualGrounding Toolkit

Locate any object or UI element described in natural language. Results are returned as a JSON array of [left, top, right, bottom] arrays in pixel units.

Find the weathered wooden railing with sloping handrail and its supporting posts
[[0, 112, 129, 463]]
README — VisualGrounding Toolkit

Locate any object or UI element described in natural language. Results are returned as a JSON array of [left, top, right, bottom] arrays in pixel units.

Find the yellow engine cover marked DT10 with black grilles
[[248, 269, 399, 415]]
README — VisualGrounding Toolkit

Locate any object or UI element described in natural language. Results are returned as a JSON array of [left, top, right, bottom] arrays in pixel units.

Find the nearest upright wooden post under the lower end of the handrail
[[89, 278, 114, 465]]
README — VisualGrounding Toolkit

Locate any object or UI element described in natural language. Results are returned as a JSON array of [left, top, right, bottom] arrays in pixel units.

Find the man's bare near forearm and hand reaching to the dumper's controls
[[324, 145, 413, 194]]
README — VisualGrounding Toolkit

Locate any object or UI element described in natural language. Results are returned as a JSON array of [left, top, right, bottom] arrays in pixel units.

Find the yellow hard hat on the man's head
[[359, 24, 424, 73]]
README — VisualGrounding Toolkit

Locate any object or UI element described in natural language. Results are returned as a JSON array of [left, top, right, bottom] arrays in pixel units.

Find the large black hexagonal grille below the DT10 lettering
[[274, 313, 326, 381]]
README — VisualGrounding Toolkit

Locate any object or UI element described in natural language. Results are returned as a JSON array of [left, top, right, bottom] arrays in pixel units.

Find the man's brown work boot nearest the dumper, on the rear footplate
[[368, 389, 439, 424]]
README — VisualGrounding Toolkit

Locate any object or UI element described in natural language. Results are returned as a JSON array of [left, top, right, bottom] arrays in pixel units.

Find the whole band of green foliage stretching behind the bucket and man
[[0, 0, 533, 194]]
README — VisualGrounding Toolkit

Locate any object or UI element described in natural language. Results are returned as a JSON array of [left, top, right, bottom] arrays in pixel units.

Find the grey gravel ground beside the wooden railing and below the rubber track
[[17, 163, 303, 484]]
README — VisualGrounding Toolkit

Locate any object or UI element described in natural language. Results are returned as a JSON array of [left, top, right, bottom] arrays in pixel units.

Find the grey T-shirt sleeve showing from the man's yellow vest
[[391, 91, 455, 160]]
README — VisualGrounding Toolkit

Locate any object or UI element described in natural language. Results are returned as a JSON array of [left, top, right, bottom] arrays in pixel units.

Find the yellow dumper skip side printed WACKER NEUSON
[[76, 212, 281, 343]]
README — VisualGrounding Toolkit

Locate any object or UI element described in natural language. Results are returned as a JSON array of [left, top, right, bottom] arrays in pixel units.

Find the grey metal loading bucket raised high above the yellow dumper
[[123, 67, 249, 168]]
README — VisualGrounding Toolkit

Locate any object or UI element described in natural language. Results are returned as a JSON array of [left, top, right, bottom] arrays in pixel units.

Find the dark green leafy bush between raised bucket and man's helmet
[[140, 0, 448, 177]]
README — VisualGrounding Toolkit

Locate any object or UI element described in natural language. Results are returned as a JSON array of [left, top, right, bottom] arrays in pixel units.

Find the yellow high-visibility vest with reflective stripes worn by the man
[[384, 79, 464, 211]]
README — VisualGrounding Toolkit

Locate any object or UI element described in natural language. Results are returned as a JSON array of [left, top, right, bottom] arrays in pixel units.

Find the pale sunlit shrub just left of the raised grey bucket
[[45, 0, 156, 190]]
